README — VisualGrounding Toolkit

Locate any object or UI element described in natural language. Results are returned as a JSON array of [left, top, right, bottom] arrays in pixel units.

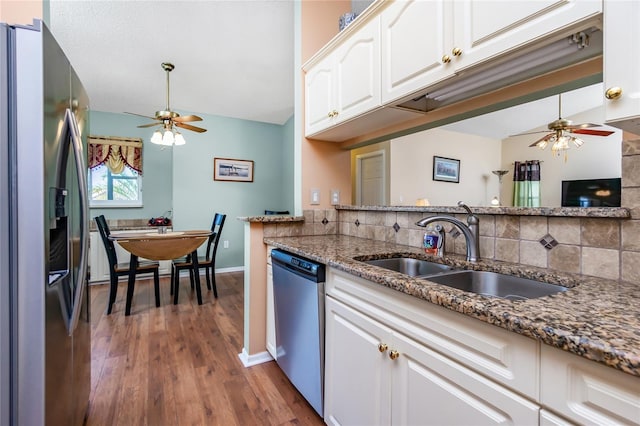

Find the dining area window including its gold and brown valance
[[88, 136, 142, 207]]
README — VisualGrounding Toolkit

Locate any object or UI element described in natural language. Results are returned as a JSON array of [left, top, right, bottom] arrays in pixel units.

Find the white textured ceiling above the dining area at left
[[49, 0, 294, 124]]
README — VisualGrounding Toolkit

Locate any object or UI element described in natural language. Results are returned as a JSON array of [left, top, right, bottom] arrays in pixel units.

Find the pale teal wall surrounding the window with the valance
[[89, 111, 173, 219]]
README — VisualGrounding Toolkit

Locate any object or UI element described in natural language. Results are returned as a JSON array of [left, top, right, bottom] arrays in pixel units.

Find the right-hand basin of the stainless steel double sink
[[426, 271, 568, 300]]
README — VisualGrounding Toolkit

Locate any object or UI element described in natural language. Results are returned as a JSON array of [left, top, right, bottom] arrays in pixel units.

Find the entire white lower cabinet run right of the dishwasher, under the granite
[[324, 268, 640, 426]]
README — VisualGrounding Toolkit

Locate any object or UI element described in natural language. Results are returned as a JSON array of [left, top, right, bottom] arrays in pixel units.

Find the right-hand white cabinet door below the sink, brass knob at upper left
[[391, 334, 540, 426]]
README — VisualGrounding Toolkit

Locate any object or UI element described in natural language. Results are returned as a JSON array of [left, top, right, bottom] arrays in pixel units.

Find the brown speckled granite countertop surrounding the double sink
[[264, 235, 640, 376]]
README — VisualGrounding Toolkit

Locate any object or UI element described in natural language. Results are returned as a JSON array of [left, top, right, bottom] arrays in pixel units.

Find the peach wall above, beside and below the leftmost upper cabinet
[[300, 0, 351, 210]]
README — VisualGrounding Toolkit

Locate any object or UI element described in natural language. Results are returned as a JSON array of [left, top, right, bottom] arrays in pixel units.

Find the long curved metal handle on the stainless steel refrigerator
[[64, 108, 89, 335]]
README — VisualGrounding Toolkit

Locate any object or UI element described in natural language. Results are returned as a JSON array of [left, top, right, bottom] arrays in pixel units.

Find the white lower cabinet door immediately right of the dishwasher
[[324, 297, 391, 426]]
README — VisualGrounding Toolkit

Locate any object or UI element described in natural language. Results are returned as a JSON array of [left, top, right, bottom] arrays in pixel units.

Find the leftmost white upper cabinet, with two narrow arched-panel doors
[[305, 17, 380, 136]]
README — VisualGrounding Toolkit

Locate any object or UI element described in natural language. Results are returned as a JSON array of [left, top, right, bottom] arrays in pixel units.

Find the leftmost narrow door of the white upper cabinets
[[304, 55, 336, 136]]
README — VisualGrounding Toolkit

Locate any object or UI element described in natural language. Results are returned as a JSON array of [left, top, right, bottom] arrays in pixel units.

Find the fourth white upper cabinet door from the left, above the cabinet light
[[450, 0, 609, 71]]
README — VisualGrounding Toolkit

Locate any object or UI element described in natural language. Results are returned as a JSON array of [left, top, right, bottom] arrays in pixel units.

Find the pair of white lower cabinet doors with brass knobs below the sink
[[325, 297, 539, 425]]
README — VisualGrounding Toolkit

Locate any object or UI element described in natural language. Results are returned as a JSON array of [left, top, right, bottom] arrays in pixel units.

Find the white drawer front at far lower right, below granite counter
[[540, 345, 640, 425]]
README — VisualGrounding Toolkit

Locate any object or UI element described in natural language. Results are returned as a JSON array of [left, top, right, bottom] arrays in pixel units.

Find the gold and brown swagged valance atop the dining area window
[[87, 136, 142, 175]]
